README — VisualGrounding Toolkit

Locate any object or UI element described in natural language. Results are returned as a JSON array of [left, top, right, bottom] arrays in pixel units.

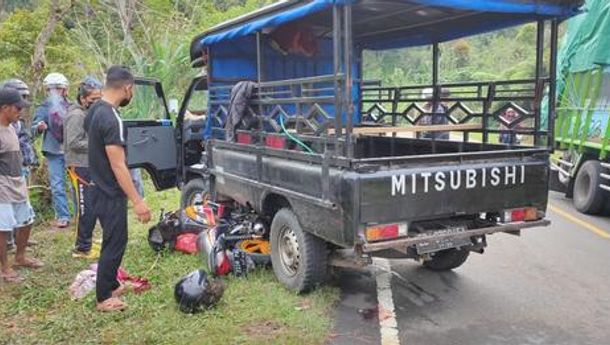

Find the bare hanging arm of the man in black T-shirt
[[105, 145, 151, 223]]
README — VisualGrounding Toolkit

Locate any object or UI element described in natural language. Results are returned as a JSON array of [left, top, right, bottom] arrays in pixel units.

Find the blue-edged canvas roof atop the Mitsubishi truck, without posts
[[191, 0, 583, 60]]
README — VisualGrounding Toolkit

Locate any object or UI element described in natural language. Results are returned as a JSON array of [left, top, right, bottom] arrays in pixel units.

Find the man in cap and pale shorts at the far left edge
[[0, 88, 43, 283]]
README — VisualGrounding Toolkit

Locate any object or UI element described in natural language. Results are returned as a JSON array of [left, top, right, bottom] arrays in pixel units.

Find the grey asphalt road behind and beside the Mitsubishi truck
[[329, 193, 610, 345]]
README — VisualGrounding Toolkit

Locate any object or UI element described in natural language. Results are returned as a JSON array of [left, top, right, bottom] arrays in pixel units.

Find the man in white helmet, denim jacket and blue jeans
[[32, 73, 70, 228]]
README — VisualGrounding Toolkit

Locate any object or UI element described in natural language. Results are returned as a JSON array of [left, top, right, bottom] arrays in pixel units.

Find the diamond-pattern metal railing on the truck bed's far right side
[[361, 80, 549, 144]]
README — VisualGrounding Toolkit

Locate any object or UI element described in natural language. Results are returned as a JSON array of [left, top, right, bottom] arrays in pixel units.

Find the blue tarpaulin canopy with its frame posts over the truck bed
[[197, 0, 582, 157]]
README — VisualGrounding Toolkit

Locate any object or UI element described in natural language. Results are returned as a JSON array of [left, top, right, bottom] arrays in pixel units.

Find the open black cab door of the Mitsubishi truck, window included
[[121, 78, 178, 190]]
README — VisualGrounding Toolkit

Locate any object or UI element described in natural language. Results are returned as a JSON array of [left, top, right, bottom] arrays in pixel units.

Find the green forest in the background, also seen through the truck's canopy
[[0, 0, 560, 218]]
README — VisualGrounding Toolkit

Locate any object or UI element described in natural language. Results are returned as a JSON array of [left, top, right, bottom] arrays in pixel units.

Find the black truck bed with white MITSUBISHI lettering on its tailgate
[[210, 137, 549, 247]]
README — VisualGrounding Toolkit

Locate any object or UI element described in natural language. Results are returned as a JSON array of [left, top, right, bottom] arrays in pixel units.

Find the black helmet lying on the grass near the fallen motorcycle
[[174, 270, 225, 314]]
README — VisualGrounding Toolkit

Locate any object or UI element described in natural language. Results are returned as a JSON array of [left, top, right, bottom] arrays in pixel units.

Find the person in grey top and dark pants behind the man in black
[[64, 77, 102, 258]]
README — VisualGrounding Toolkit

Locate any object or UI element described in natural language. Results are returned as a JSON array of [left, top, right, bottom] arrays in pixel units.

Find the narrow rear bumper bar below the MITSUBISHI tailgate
[[362, 219, 551, 253]]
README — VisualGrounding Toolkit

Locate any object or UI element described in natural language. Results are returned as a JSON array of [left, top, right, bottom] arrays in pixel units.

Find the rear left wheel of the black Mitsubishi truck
[[271, 208, 328, 293]]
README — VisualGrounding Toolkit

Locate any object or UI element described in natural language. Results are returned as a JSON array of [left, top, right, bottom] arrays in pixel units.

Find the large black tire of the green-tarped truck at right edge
[[574, 160, 605, 214]]
